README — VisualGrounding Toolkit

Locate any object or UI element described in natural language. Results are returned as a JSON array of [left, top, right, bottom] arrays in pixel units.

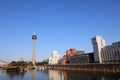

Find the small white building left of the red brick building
[[49, 51, 60, 64]]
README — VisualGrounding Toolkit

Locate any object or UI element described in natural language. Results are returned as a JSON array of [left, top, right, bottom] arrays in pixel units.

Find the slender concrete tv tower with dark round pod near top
[[32, 33, 37, 66]]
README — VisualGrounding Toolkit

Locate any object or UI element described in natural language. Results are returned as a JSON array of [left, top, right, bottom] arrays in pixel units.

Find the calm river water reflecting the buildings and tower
[[0, 70, 120, 80]]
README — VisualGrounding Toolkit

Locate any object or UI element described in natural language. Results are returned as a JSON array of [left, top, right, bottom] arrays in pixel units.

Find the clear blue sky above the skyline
[[0, 0, 120, 62]]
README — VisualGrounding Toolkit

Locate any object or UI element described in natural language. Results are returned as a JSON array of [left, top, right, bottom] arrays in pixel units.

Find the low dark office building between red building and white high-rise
[[69, 53, 94, 64]]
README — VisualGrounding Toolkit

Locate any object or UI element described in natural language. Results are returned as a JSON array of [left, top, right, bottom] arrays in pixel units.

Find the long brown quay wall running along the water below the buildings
[[44, 63, 120, 72]]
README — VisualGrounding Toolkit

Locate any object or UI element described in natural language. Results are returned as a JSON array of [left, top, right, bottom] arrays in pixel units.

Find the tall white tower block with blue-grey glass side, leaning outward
[[92, 35, 106, 63]]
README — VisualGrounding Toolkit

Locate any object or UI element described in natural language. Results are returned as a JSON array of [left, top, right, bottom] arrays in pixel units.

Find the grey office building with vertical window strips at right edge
[[101, 42, 120, 63]]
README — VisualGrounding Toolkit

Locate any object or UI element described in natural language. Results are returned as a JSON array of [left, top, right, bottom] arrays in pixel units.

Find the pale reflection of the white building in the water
[[49, 70, 63, 80]]
